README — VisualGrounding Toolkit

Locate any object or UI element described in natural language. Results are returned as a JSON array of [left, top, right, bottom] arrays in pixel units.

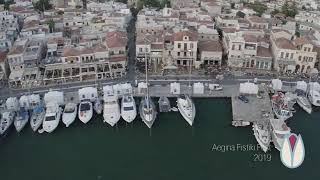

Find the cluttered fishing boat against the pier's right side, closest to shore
[[271, 92, 293, 121]]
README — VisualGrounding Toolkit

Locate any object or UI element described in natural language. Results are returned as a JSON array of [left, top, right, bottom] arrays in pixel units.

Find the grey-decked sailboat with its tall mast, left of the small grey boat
[[139, 46, 157, 128]]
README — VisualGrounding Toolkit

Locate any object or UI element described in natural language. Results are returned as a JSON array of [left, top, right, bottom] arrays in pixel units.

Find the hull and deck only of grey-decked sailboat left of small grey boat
[[139, 96, 157, 128]]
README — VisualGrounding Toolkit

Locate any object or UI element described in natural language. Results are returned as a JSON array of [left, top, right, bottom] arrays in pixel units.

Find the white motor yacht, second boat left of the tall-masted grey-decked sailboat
[[103, 94, 120, 126]]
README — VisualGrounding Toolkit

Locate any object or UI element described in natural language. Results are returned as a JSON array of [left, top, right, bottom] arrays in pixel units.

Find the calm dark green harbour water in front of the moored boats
[[0, 99, 320, 180]]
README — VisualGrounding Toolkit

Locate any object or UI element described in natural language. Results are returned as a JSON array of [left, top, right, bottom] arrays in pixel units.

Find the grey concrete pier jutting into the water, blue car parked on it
[[231, 85, 273, 126]]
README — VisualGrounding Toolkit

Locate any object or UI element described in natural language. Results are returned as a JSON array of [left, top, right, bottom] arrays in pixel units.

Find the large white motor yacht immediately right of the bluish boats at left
[[42, 102, 62, 133]]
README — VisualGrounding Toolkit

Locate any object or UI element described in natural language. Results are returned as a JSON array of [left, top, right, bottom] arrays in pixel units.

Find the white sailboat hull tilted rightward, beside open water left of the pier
[[177, 95, 196, 126]]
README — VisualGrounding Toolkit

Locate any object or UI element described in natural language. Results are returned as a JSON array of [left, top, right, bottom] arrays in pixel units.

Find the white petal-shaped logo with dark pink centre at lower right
[[280, 133, 305, 168]]
